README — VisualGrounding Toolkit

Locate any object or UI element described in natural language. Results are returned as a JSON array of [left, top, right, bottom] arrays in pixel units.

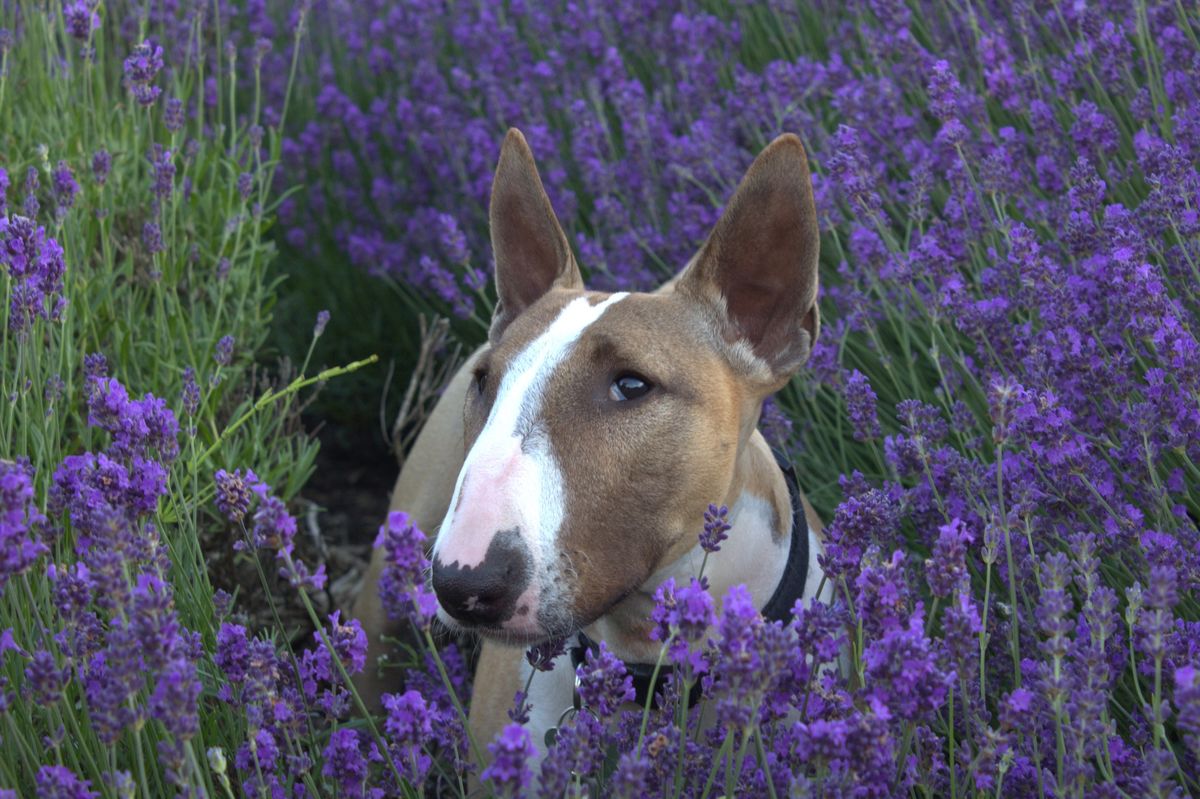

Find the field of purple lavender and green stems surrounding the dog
[[0, 0, 1200, 799]]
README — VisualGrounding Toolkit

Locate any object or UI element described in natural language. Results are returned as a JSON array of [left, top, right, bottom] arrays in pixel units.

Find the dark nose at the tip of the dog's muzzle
[[433, 528, 529, 626]]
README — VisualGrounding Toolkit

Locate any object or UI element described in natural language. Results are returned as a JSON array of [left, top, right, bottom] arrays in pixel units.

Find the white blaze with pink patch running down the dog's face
[[433, 293, 628, 590]]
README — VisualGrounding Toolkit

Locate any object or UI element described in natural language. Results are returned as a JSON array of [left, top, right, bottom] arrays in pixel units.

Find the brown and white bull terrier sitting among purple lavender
[[354, 128, 828, 756]]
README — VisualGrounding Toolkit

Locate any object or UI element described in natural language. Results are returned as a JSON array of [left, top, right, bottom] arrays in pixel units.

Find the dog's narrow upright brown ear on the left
[[488, 127, 583, 344]]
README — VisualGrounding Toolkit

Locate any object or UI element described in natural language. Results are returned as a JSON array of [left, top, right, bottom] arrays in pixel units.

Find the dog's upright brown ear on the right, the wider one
[[676, 133, 820, 384]]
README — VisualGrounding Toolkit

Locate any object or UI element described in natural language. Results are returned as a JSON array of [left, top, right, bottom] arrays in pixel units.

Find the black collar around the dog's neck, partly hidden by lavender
[[570, 449, 809, 709]]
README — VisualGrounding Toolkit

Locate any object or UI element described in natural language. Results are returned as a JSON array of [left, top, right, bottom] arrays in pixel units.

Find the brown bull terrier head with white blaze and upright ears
[[433, 130, 818, 642]]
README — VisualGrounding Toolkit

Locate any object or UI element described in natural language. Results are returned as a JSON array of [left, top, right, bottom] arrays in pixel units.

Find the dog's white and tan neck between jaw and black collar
[[584, 432, 793, 662]]
